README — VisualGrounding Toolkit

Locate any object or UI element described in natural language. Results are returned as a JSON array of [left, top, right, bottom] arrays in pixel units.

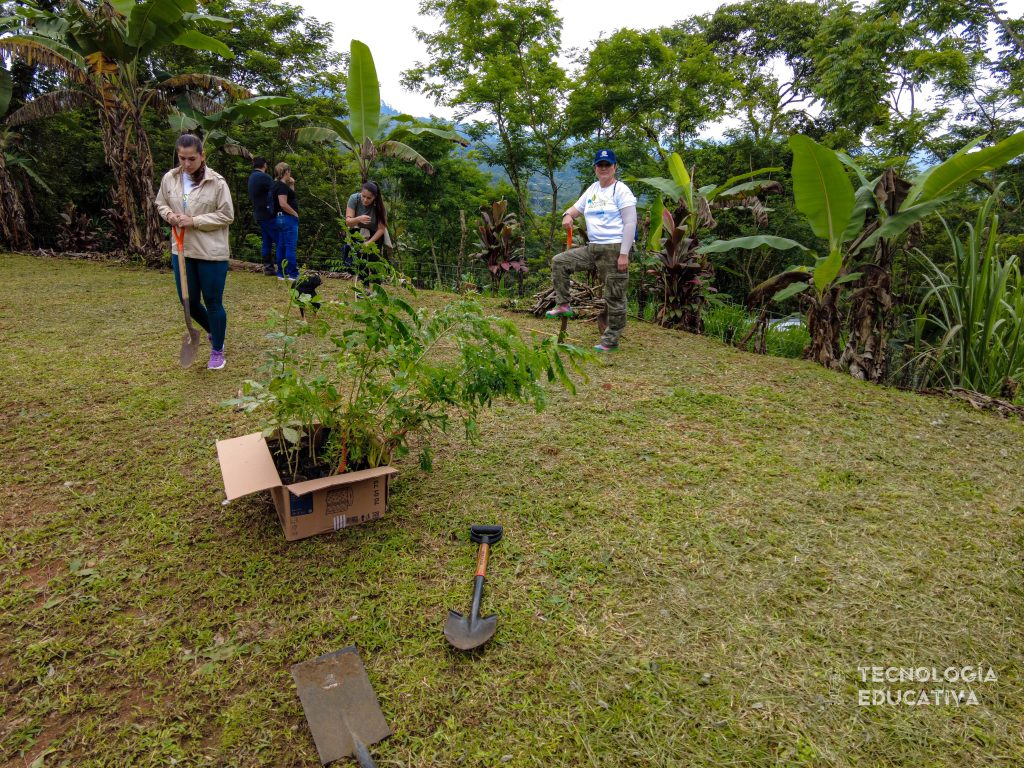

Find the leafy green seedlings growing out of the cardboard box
[[224, 264, 589, 480]]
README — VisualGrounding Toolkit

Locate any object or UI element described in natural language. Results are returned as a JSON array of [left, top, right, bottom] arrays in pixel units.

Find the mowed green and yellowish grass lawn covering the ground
[[0, 255, 1024, 768]]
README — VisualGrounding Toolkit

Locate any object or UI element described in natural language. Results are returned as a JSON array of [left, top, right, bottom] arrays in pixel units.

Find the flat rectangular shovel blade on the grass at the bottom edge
[[292, 645, 391, 768]]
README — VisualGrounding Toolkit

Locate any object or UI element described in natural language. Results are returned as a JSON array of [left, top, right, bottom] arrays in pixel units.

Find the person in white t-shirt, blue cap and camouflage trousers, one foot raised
[[546, 150, 637, 352]]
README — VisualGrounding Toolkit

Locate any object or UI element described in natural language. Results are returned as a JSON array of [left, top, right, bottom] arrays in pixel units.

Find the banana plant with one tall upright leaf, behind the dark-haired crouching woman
[[296, 40, 469, 181]]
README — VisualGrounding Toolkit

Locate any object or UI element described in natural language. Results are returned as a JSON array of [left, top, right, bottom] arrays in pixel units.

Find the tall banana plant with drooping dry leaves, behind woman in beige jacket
[[0, 0, 242, 259]]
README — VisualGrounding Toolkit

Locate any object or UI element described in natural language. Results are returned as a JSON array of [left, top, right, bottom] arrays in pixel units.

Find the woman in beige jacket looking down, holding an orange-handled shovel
[[157, 133, 234, 371]]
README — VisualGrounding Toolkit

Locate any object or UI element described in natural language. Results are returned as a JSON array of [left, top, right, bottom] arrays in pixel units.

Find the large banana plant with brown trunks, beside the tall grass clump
[[741, 131, 1024, 381]]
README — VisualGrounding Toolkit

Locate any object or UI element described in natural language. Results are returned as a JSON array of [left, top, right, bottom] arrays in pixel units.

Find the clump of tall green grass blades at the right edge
[[914, 189, 1024, 397]]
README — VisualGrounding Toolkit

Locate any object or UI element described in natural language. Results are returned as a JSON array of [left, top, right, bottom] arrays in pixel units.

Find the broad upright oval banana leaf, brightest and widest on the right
[[790, 135, 855, 250]]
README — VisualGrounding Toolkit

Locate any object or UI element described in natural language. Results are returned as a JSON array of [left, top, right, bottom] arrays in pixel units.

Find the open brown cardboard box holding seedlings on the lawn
[[217, 432, 397, 542]]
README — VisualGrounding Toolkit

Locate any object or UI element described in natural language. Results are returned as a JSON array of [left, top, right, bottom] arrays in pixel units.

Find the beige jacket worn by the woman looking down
[[157, 166, 234, 261]]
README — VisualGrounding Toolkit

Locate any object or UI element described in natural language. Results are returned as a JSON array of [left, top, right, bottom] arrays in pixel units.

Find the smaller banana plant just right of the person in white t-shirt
[[638, 153, 782, 333]]
